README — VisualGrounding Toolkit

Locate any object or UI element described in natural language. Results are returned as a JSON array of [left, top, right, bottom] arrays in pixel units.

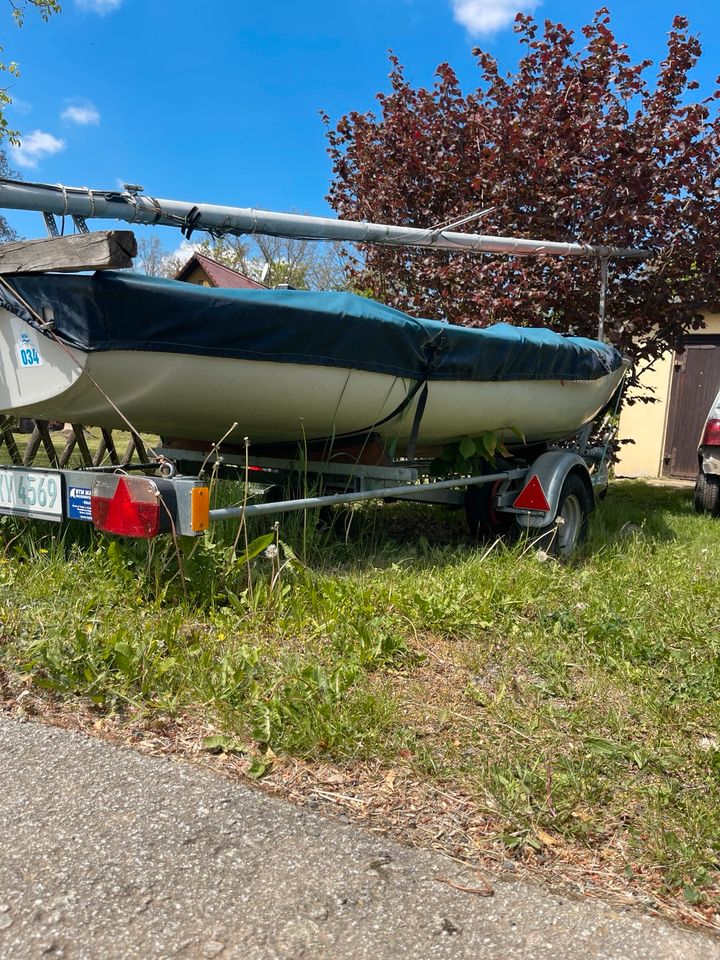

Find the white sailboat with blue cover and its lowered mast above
[[0, 181, 642, 455]]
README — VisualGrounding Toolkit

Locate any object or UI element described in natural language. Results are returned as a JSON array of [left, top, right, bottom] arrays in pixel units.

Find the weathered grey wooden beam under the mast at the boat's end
[[0, 230, 137, 274]]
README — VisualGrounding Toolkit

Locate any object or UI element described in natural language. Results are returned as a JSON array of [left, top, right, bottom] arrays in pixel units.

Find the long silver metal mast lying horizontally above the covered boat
[[0, 179, 649, 259]]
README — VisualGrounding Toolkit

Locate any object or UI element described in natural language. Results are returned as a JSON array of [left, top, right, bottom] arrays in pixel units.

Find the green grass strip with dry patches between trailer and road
[[0, 482, 720, 923]]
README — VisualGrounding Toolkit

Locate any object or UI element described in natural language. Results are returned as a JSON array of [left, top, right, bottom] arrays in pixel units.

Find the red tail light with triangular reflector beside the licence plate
[[90, 474, 163, 540]]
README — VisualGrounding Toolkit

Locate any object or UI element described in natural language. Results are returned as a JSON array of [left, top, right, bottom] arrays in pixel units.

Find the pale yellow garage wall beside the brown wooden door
[[615, 314, 720, 477]]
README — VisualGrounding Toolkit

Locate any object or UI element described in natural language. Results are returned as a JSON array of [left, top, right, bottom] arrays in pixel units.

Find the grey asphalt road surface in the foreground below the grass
[[0, 717, 720, 960]]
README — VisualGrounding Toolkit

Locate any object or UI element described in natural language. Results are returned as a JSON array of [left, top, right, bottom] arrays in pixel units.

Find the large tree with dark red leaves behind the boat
[[325, 8, 720, 378]]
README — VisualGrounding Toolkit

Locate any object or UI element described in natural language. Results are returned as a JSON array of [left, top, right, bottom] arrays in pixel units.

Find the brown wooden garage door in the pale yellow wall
[[663, 336, 720, 478]]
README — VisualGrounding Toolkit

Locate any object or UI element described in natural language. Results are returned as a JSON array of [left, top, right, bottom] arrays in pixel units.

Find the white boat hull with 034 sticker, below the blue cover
[[0, 308, 624, 452]]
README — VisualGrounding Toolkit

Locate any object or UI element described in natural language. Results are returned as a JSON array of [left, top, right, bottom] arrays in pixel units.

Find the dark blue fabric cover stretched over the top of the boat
[[3, 271, 623, 381]]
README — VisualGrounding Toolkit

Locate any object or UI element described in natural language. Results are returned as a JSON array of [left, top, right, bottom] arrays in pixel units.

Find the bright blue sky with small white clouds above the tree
[[2, 0, 720, 249]]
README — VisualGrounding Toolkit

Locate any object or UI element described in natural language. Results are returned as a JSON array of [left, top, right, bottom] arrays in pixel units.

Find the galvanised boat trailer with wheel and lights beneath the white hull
[[0, 417, 612, 556]]
